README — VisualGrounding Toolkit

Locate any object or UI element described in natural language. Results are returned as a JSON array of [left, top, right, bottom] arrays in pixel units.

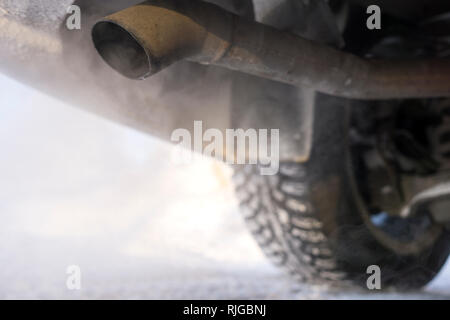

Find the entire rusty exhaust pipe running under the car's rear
[[92, 0, 450, 99]]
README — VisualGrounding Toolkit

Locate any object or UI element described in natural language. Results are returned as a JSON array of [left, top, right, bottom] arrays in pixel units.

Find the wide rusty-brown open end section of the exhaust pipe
[[92, 0, 231, 79]]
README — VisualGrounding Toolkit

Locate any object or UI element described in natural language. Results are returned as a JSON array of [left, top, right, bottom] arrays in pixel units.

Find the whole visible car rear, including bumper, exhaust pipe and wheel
[[0, 0, 450, 289]]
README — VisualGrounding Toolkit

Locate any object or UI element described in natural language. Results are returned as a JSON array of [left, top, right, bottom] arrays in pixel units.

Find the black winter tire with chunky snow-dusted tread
[[233, 91, 450, 290]]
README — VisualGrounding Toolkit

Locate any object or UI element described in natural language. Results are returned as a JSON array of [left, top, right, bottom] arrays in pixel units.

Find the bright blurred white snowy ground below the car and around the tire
[[0, 76, 450, 299]]
